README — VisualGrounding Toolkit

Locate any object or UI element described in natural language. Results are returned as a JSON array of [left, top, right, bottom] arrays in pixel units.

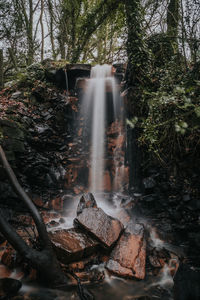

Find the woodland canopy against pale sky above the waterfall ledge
[[0, 0, 200, 70]]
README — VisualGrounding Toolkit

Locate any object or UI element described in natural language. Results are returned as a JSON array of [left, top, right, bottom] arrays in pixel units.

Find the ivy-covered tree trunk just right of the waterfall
[[125, 0, 150, 193]]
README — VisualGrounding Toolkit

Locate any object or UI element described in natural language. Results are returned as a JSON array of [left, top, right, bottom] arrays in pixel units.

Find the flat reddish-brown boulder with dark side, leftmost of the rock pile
[[49, 228, 99, 264]]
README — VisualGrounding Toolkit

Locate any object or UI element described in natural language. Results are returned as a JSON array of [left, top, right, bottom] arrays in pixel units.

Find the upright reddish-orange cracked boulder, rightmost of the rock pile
[[106, 222, 146, 279]]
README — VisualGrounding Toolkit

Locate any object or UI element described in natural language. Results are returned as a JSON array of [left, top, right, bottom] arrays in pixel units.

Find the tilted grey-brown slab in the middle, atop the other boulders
[[74, 208, 123, 247]]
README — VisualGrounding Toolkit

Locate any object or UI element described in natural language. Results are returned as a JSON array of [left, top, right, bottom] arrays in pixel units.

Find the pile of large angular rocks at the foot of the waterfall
[[49, 193, 146, 279]]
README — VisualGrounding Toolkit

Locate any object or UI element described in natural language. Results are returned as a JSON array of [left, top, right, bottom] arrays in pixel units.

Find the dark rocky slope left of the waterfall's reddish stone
[[0, 62, 84, 210]]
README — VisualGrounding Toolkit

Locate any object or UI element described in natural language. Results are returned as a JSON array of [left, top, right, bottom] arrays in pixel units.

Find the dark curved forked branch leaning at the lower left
[[0, 146, 67, 287]]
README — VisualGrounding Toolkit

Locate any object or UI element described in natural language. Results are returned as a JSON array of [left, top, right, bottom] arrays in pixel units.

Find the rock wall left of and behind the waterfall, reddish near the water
[[0, 61, 128, 210]]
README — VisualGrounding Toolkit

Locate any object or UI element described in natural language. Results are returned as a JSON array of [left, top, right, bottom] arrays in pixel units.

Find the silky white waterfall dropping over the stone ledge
[[81, 64, 124, 193]]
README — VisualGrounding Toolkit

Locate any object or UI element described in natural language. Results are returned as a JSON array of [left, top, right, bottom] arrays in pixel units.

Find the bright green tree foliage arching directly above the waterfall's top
[[56, 0, 124, 63]]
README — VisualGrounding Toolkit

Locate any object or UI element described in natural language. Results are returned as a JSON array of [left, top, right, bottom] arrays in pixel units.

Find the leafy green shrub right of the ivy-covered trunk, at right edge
[[139, 76, 200, 159]]
